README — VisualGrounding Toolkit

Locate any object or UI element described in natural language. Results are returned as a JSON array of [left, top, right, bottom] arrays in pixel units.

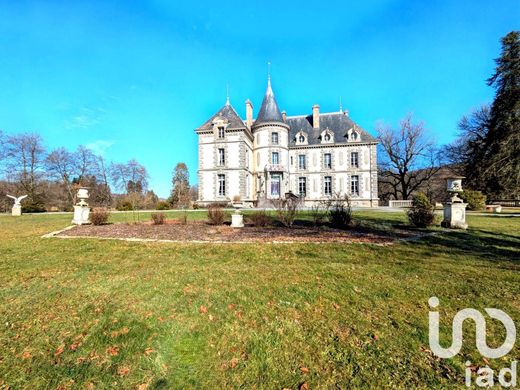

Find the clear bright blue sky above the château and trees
[[0, 0, 520, 196]]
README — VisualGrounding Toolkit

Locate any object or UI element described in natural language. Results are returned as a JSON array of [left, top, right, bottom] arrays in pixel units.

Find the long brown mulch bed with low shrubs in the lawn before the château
[[58, 221, 417, 244]]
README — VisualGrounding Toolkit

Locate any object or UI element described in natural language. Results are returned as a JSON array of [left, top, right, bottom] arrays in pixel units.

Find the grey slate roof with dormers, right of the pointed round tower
[[286, 112, 377, 146]]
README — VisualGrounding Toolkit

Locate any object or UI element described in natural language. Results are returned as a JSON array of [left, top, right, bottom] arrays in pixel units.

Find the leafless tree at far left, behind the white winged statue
[[5, 133, 45, 203]]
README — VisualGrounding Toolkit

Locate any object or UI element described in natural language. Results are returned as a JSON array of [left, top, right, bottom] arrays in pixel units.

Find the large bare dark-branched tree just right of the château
[[377, 115, 441, 199]]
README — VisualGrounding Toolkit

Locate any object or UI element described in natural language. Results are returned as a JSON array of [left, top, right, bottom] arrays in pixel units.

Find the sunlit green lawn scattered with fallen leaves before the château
[[0, 211, 520, 389]]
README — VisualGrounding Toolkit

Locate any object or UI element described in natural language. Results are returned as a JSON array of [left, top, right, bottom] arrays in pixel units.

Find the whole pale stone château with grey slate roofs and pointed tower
[[196, 79, 378, 207]]
